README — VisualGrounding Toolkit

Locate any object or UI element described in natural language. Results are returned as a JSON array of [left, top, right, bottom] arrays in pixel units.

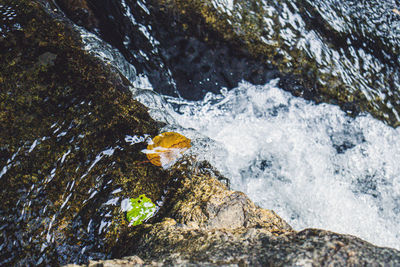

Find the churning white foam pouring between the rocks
[[162, 81, 400, 249]]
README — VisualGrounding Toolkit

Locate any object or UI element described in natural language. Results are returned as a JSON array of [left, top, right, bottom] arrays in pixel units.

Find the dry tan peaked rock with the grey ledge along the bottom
[[70, 162, 400, 266]]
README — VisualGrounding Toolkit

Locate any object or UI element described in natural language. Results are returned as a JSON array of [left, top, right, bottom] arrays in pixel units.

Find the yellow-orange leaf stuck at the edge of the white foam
[[145, 132, 191, 168]]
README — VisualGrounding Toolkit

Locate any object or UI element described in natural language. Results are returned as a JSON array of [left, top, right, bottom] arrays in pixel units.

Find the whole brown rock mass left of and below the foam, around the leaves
[[0, 0, 400, 266]]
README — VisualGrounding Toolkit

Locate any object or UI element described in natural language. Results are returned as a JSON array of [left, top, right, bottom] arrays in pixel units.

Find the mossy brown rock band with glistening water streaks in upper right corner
[[152, 0, 400, 126]]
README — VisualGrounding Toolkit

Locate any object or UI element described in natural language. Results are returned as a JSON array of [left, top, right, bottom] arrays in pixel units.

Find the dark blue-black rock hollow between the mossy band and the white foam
[[54, 0, 289, 100]]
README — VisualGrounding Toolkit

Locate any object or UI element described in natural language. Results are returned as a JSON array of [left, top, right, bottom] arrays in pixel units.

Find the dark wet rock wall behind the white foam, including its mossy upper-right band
[[57, 0, 400, 127]]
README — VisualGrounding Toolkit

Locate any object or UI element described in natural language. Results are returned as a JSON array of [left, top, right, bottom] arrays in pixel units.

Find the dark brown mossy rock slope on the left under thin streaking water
[[0, 0, 171, 265]]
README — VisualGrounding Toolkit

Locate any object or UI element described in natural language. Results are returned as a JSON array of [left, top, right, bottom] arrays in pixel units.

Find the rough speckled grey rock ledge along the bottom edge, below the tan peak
[[65, 227, 400, 266]]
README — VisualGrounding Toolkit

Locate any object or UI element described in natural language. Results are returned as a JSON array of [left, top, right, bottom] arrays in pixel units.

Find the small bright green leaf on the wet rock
[[126, 195, 156, 226]]
